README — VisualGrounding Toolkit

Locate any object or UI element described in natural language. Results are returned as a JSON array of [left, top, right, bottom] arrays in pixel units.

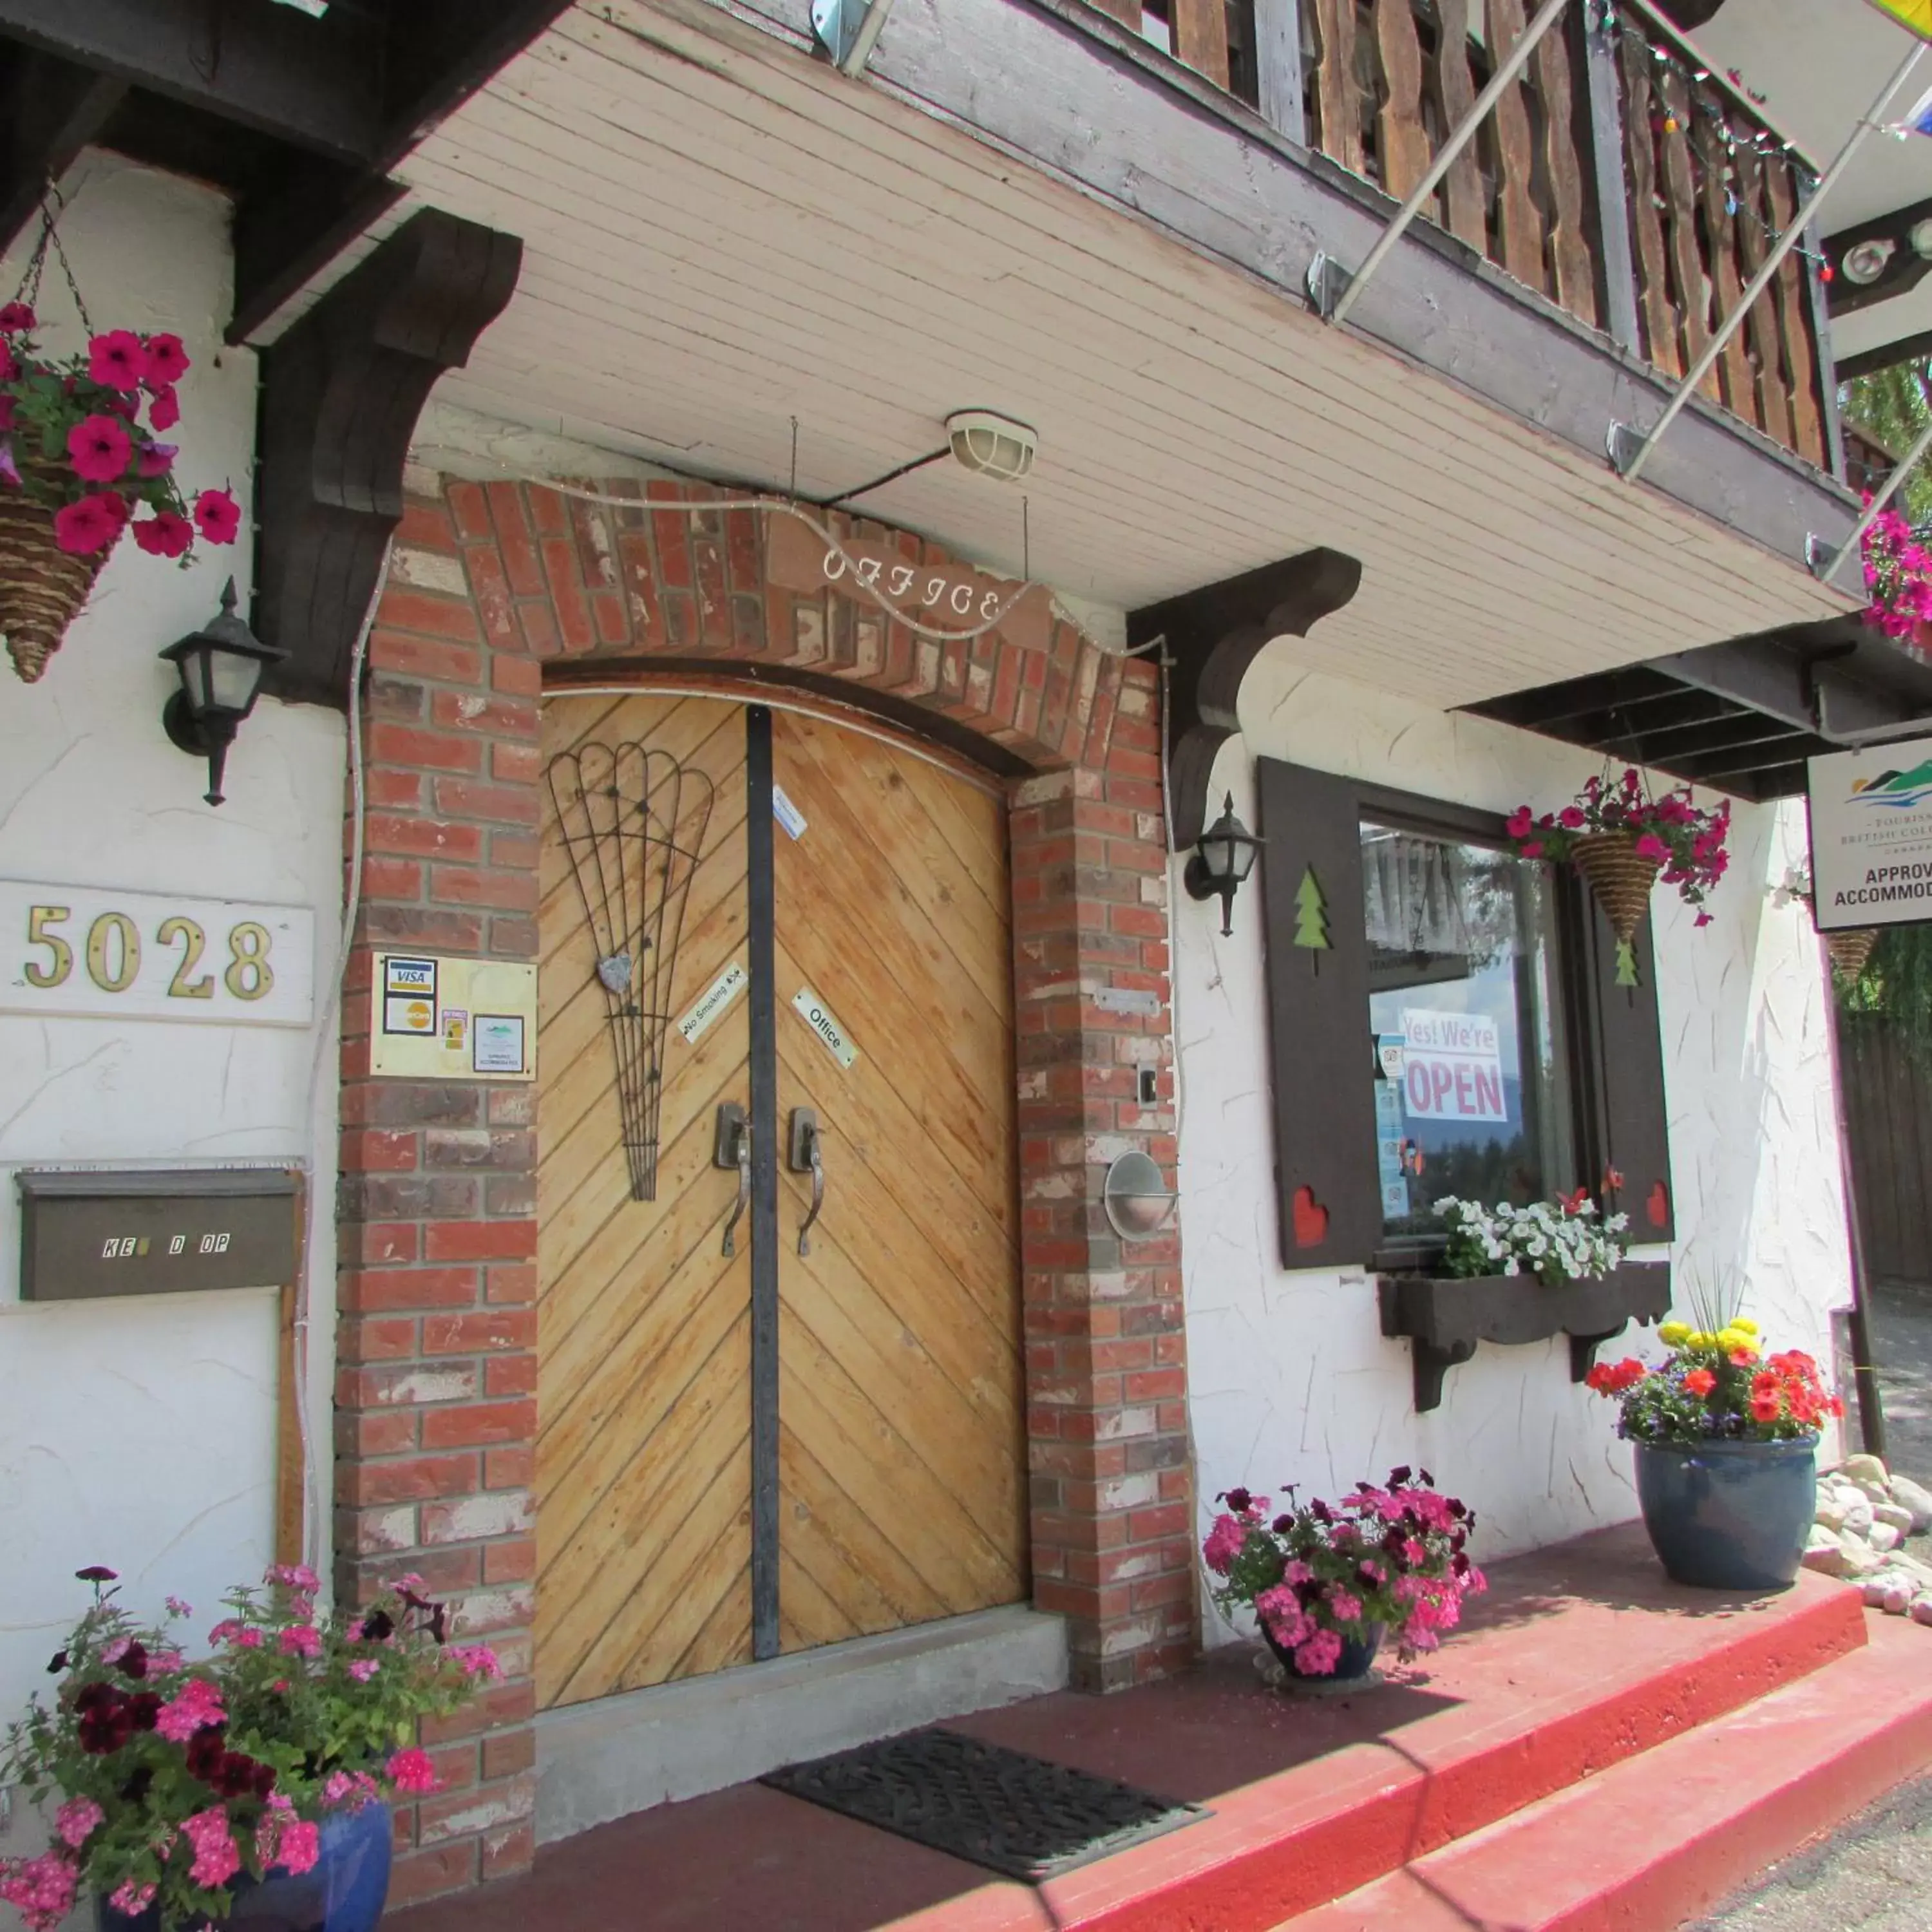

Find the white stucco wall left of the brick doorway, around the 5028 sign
[[0, 156, 344, 1770]]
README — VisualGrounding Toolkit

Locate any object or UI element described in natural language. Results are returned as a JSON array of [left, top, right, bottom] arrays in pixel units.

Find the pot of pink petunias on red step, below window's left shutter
[[1202, 1468, 1484, 1679]]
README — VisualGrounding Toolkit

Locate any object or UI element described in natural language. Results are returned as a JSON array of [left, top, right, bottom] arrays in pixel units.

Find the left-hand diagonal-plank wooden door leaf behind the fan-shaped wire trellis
[[537, 694, 752, 1706]]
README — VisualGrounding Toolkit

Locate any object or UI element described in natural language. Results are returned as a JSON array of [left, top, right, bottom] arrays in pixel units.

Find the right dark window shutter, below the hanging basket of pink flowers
[[1567, 879, 1677, 1240]]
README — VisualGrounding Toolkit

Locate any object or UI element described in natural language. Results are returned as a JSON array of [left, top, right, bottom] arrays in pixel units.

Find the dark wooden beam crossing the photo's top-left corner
[[0, 0, 386, 164]]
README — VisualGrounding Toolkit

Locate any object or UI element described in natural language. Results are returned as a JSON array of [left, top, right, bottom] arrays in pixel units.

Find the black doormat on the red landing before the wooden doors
[[759, 1729, 1208, 1886]]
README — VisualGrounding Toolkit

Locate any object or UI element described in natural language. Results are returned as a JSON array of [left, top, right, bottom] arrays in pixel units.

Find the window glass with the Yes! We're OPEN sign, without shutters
[[1360, 819, 1577, 1242]]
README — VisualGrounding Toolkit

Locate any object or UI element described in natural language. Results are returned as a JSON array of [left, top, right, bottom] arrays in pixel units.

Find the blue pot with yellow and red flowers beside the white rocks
[[1588, 1310, 1843, 1590]]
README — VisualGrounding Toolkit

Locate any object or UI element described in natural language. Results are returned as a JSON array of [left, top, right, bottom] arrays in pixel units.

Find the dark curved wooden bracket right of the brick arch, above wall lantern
[[1126, 551, 1362, 852]]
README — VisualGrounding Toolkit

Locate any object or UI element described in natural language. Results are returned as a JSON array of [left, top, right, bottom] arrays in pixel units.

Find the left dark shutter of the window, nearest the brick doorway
[[1260, 757, 1381, 1267]]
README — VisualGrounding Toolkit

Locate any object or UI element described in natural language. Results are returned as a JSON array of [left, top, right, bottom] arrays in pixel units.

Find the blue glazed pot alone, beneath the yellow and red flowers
[[1636, 1439, 1818, 1590]]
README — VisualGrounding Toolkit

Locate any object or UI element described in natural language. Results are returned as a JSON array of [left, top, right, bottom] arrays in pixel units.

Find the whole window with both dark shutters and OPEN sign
[[1256, 759, 1673, 1269]]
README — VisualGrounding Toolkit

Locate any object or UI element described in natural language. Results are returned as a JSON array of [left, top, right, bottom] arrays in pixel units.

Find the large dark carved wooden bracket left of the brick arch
[[255, 209, 524, 705]]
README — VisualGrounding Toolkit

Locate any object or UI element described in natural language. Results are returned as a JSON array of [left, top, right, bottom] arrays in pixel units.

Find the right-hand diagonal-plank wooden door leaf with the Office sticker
[[773, 713, 1028, 1650]]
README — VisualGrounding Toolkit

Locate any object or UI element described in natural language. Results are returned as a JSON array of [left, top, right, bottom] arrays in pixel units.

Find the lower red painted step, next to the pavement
[[1267, 1615, 1932, 1932]]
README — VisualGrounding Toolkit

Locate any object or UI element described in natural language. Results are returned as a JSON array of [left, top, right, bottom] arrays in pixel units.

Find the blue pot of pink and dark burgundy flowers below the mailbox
[[0, 1565, 497, 1932]]
